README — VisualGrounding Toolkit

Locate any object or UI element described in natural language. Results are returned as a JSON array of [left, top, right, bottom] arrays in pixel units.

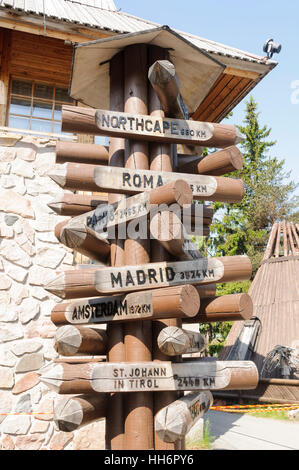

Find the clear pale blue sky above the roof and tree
[[115, 0, 299, 193]]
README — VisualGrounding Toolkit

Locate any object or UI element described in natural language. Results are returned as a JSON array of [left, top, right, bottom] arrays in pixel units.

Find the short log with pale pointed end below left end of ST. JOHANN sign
[[54, 393, 109, 432]]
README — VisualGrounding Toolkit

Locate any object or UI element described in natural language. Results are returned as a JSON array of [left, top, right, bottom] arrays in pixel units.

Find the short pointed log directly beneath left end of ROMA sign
[[47, 193, 108, 216]]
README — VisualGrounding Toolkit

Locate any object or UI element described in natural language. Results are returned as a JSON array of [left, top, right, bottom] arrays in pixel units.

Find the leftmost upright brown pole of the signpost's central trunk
[[106, 52, 126, 450]]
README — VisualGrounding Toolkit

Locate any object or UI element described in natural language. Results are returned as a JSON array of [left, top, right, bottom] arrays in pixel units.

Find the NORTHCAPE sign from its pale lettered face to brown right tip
[[95, 109, 242, 148]]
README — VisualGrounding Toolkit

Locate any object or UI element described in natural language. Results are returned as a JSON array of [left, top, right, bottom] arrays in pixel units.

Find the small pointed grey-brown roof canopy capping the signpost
[[70, 26, 225, 114]]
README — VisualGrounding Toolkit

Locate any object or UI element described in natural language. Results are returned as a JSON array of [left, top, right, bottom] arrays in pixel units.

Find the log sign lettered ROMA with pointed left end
[[48, 163, 244, 202]]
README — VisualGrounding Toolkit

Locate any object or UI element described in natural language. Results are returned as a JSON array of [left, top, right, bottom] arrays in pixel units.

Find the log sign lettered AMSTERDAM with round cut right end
[[51, 284, 200, 326]]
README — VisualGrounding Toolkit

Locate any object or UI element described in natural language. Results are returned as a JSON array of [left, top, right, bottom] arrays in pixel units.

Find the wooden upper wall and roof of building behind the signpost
[[0, 0, 276, 138]]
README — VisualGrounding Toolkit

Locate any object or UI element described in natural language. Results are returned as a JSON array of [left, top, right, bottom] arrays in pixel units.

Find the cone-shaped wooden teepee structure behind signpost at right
[[217, 221, 299, 403]]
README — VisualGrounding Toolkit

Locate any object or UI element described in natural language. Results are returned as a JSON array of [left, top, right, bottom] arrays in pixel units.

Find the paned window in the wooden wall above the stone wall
[[8, 79, 74, 134]]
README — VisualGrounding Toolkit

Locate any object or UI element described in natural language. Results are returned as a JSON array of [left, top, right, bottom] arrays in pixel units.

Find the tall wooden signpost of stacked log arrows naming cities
[[41, 39, 258, 450]]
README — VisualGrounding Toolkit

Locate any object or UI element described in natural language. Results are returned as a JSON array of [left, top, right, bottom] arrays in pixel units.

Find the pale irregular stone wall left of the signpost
[[0, 134, 104, 450]]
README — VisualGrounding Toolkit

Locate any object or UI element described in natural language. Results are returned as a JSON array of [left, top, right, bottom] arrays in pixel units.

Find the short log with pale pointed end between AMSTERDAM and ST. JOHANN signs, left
[[55, 325, 108, 356]]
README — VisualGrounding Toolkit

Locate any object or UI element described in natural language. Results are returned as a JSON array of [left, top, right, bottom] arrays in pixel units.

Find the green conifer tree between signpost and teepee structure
[[200, 96, 299, 355]]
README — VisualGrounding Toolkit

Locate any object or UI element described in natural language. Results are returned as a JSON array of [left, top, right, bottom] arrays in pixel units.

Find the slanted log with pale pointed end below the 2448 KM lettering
[[155, 391, 213, 442]]
